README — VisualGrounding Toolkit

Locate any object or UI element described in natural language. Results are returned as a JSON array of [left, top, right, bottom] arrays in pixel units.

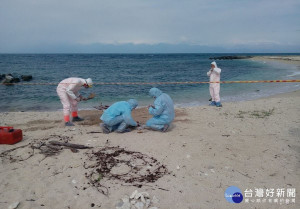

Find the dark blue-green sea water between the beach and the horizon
[[0, 54, 300, 112]]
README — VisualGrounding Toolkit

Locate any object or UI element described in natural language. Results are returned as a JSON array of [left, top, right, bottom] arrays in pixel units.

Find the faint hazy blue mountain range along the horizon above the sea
[[0, 43, 300, 53]]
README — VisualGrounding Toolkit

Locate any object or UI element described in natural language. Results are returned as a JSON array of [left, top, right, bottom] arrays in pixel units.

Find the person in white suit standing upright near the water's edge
[[207, 62, 222, 107]]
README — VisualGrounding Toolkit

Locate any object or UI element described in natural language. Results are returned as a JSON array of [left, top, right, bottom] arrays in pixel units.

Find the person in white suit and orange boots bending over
[[56, 78, 93, 126]]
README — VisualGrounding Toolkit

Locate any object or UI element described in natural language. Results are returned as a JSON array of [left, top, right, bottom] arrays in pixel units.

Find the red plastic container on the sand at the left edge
[[0, 126, 23, 144]]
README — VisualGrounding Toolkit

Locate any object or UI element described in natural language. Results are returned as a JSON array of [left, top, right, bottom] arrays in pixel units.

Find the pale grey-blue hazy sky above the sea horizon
[[0, 0, 300, 53]]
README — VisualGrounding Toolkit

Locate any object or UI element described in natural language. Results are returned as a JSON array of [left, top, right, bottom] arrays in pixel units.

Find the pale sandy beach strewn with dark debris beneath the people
[[0, 57, 300, 209]]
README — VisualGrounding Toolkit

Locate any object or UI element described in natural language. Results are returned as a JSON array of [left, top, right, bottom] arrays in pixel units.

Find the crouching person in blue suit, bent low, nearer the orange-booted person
[[100, 99, 138, 134]]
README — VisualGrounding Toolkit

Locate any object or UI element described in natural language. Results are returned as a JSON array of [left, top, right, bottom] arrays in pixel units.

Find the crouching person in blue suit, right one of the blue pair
[[146, 88, 175, 132]]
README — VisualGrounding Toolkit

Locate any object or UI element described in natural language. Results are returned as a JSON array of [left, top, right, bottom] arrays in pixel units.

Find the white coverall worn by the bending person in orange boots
[[56, 78, 86, 116]]
